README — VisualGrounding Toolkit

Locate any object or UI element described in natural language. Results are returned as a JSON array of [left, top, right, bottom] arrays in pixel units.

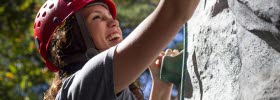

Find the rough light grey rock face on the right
[[186, 0, 280, 100]]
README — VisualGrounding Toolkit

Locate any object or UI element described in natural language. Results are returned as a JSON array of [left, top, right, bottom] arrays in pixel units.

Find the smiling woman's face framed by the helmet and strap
[[82, 5, 123, 52]]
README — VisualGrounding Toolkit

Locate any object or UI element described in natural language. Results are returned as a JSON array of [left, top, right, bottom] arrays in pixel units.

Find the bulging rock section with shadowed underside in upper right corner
[[228, 0, 280, 52]]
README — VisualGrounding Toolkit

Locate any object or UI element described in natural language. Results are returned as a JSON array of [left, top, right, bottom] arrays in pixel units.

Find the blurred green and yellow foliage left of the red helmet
[[0, 0, 52, 100]]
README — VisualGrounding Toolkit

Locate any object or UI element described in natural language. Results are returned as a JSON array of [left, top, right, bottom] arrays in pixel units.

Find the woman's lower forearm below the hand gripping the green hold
[[150, 81, 173, 100]]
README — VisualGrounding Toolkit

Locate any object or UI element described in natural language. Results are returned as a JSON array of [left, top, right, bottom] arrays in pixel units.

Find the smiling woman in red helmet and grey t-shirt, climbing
[[34, 0, 198, 100]]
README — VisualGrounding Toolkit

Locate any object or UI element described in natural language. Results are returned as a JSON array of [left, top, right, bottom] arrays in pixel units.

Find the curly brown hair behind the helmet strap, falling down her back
[[44, 18, 74, 100]]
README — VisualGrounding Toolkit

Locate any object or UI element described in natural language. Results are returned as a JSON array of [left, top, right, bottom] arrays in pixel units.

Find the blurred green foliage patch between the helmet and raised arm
[[115, 0, 157, 30]]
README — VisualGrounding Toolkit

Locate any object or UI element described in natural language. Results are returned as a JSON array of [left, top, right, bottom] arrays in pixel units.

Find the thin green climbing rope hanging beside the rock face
[[180, 23, 188, 100]]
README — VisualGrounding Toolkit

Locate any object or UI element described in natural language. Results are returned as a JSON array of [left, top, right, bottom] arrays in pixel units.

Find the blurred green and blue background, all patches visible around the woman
[[0, 0, 183, 100]]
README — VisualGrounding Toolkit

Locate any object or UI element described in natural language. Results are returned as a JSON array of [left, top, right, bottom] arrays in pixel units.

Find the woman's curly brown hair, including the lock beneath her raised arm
[[44, 16, 144, 100]]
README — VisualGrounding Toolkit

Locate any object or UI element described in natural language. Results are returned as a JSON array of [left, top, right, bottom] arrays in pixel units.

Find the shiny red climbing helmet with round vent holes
[[34, 0, 116, 72]]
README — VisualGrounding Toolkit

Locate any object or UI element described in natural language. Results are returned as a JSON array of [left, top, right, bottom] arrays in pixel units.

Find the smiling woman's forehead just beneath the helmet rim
[[82, 5, 111, 17]]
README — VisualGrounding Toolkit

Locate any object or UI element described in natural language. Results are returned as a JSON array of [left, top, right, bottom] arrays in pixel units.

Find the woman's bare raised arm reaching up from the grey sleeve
[[113, 0, 199, 93]]
